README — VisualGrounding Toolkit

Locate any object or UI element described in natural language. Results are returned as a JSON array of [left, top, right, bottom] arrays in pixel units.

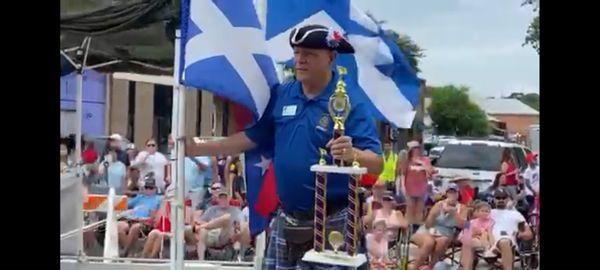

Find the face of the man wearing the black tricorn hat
[[294, 47, 335, 82]]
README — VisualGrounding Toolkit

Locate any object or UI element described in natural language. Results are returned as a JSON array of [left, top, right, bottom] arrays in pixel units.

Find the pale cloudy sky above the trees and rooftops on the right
[[352, 0, 540, 98]]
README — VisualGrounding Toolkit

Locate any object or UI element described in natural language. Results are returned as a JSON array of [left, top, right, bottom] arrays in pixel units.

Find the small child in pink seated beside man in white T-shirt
[[459, 202, 495, 257]]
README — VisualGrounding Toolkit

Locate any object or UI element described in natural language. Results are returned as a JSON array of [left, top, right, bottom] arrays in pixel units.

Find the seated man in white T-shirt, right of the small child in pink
[[461, 188, 533, 270]]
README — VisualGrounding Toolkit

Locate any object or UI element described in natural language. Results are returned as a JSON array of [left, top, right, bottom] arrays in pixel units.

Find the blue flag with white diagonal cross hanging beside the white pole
[[180, 0, 278, 120]]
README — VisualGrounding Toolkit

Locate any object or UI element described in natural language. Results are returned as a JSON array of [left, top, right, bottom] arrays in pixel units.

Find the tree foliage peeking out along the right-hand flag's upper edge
[[366, 11, 425, 73]]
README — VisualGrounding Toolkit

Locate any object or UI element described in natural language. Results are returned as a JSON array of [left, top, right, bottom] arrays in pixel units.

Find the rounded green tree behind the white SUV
[[429, 85, 490, 136]]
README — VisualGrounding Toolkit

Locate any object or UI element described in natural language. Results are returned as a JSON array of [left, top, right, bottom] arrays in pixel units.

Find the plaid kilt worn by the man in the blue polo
[[263, 209, 349, 270]]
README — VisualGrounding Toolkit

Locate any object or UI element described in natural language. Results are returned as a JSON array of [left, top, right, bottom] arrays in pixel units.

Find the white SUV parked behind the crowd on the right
[[433, 140, 530, 190]]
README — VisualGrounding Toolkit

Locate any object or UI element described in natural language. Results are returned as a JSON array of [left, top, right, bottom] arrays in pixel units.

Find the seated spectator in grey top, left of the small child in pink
[[408, 183, 468, 269]]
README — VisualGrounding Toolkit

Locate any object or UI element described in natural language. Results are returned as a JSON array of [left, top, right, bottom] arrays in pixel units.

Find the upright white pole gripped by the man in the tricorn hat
[[171, 29, 185, 270]]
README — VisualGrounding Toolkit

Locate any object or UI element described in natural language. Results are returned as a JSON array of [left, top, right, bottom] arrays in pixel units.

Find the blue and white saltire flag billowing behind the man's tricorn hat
[[266, 0, 420, 128]]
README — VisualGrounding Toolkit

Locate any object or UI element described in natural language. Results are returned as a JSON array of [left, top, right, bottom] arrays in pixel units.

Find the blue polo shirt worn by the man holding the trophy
[[245, 72, 381, 211]]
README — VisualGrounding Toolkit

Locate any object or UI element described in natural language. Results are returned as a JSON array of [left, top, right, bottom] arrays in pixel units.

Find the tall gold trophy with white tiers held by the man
[[302, 66, 367, 267]]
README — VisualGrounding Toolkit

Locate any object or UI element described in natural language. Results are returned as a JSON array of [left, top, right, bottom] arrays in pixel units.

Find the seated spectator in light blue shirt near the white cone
[[117, 177, 161, 257]]
